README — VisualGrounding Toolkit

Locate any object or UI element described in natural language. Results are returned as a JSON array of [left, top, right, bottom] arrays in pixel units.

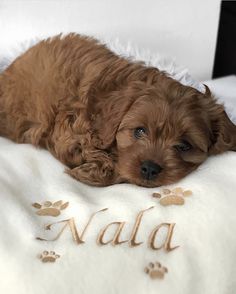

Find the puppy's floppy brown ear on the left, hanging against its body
[[92, 90, 135, 149]]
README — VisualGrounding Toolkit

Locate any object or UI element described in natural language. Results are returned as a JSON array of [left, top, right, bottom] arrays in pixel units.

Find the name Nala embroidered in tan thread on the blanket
[[36, 206, 179, 252]]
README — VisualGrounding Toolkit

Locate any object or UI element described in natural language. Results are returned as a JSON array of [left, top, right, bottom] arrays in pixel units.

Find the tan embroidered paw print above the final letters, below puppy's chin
[[152, 187, 193, 206]]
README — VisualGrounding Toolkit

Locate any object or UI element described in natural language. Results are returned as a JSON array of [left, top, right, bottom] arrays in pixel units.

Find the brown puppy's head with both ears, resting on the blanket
[[92, 79, 236, 187]]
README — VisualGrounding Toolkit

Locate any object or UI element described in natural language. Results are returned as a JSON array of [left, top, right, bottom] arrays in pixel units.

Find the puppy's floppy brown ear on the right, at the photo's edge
[[205, 86, 236, 154]]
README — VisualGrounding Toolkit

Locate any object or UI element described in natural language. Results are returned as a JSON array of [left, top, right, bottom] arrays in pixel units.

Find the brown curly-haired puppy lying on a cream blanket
[[0, 34, 236, 187]]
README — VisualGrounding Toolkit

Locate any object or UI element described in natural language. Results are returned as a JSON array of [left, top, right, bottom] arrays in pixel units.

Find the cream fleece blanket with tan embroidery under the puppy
[[0, 39, 236, 294]]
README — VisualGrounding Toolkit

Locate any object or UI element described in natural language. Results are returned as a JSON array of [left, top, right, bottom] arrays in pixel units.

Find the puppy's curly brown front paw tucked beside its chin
[[66, 151, 118, 187]]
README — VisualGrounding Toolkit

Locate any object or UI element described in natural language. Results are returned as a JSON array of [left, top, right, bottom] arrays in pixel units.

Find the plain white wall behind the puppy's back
[[0, 0, 220, 80]]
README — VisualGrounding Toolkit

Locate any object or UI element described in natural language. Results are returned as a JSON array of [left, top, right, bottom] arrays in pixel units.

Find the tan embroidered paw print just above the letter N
[[32, 200, 69, 216]]
